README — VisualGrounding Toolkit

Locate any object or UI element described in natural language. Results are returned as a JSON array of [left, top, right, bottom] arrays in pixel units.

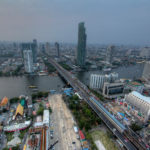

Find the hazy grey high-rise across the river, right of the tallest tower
[[106, 46, 115, 64]]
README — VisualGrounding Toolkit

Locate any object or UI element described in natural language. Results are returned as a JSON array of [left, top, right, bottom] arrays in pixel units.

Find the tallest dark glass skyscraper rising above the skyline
[[76, 22, 86, 68]]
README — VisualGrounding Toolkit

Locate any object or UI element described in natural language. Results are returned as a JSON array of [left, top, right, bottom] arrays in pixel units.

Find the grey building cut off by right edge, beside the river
[[142, 61, 150, 82]]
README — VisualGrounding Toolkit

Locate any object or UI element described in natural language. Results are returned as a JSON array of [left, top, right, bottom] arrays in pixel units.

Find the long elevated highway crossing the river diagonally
[[48, 58, 146, 150]]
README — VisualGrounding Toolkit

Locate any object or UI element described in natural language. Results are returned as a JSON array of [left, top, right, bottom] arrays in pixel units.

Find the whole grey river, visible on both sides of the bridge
[[0, 64, 143, 99]]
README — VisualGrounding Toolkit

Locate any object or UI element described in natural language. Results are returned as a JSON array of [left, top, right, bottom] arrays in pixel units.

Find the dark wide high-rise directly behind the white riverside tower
[[21, 41, 37, 63]]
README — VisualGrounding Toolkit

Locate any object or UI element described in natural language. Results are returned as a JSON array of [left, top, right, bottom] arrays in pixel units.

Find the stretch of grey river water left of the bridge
[[0, 76, 65, 98]]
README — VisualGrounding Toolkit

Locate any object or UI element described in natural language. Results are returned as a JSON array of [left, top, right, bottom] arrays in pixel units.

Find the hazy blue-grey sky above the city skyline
[[0, 0, 150, 45]]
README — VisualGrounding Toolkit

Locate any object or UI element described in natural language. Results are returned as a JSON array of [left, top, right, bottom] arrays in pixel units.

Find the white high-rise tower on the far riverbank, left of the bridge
[[23, 50, 34, 73]]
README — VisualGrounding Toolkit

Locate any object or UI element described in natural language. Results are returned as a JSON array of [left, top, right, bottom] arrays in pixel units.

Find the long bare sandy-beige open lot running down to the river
[[49, 94, 81, 150]]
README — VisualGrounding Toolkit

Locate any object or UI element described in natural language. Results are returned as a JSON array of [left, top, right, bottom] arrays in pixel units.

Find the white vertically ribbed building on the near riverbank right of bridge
[[90, 73, 118, 89]]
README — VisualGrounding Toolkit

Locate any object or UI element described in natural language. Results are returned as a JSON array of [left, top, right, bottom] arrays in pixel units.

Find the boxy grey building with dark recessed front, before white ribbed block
[[103, 82, 124, 99]]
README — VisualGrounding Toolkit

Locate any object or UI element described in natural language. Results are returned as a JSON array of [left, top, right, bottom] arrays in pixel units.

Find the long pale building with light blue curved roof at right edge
[[125, 91, 150, 119]]
